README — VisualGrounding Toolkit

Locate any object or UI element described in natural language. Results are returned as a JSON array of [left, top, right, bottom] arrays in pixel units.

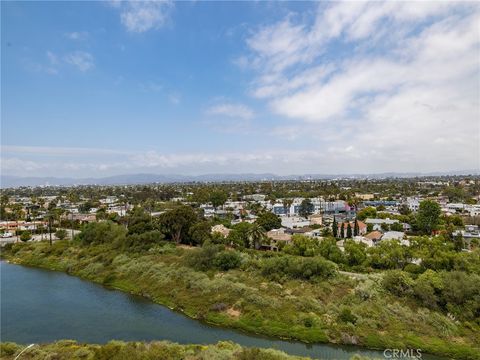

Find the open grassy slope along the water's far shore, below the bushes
[[2, 241, 480, 359]]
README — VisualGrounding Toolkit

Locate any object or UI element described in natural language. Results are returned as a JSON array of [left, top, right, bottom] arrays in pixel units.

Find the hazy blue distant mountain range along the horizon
[[0, 170, 480, 188]]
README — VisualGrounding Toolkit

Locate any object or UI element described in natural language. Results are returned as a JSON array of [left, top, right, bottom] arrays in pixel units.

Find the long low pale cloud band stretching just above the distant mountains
[[1, 143, 475, 177]]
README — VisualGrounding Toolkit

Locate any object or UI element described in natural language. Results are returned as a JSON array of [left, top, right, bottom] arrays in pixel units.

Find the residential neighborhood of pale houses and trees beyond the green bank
[[0, 177, 480, 255]]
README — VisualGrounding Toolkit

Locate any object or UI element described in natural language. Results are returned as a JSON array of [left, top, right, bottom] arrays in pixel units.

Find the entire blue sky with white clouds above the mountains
[[1, 1, 480, 177]]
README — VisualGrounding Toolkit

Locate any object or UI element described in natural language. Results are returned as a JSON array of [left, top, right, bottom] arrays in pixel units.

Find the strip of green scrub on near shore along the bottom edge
[[0, 340, 303, 360]]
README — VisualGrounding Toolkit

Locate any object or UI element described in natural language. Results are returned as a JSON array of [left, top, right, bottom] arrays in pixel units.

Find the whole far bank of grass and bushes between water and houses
[[2, 236, 480, 359]]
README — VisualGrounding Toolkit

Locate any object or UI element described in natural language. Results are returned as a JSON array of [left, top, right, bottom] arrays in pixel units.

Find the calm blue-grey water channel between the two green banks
[[0, 261, 434, 359]]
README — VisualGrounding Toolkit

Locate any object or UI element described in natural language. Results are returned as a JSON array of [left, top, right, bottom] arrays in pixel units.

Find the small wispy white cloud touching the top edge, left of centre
[[112, 0, 173, 33]]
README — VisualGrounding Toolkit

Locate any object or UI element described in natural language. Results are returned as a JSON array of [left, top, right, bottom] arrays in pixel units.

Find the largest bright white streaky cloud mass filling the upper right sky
[[241, 2, 480, 171]]
